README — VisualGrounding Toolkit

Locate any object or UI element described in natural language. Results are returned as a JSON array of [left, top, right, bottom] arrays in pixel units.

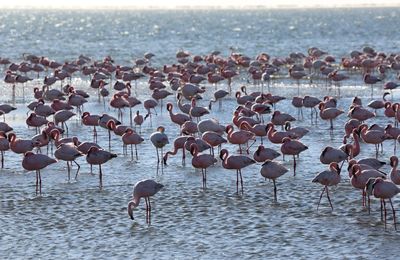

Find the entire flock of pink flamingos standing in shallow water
[[0, 47, 400, 229]]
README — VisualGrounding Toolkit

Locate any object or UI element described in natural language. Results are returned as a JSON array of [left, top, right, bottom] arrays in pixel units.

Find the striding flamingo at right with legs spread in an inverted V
[[312, 162, 340, 211]]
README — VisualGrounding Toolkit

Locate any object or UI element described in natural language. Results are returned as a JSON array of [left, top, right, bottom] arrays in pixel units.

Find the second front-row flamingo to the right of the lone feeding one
[[219, 149, 256, 193]]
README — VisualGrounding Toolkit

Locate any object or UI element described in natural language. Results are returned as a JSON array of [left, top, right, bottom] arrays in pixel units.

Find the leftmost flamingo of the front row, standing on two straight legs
[[22, 151, 57, 195]]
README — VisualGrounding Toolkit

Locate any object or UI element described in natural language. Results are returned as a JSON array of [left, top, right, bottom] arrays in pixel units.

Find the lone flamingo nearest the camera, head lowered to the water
[[128, 179, 164, 223]]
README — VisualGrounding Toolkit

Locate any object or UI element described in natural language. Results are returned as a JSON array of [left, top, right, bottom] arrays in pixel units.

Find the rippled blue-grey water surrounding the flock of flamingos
[[0, 8, 400, 259]]
